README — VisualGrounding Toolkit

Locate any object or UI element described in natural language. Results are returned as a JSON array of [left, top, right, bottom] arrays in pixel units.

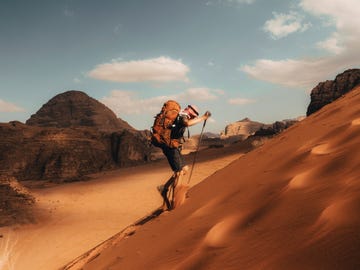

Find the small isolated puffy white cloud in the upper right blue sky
[[263, 12, 310, 39]]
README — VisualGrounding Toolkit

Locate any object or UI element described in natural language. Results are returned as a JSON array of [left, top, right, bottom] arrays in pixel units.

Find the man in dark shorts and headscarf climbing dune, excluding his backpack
[[153, 102, 211, 210]]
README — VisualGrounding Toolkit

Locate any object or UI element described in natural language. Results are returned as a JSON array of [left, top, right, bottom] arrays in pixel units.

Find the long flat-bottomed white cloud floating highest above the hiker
[[88, 56, 190, 82]]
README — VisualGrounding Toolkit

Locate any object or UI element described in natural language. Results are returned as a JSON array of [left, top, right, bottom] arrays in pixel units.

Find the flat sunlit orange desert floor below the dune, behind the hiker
[[0, 147, 242, 270]]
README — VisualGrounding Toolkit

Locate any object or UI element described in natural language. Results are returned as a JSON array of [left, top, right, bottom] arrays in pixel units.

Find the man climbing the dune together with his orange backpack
[[152, 100, 211, 210]]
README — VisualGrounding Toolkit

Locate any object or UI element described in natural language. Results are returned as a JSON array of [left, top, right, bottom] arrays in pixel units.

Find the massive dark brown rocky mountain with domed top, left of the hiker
[[0, 91, 150, 182]]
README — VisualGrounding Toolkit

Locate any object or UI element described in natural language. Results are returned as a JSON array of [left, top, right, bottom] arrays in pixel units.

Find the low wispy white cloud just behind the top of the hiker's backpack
[[100, 88, 222, 116]]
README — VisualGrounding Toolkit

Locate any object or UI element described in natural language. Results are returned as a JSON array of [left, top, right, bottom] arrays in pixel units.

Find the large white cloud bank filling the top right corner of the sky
[[240, 0, 360, 90]]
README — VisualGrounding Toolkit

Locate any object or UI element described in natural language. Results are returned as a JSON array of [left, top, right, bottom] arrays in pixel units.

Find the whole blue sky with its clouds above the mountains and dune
[[0, 0, 360, 132]]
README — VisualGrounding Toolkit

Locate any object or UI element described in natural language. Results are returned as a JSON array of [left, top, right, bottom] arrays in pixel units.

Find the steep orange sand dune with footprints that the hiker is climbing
[[79, 87, 360, 270]]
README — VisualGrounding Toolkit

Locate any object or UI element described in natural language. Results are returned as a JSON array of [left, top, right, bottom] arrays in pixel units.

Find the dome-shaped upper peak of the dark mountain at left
[[26, 90, 134, 130]]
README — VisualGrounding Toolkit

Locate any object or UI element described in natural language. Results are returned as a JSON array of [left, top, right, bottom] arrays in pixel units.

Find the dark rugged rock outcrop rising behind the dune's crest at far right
[[306, 69, 360, 116]]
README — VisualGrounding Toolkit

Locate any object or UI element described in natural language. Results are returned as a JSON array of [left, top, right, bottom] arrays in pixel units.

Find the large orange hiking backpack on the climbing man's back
[[151, 100, 181, 148]]
